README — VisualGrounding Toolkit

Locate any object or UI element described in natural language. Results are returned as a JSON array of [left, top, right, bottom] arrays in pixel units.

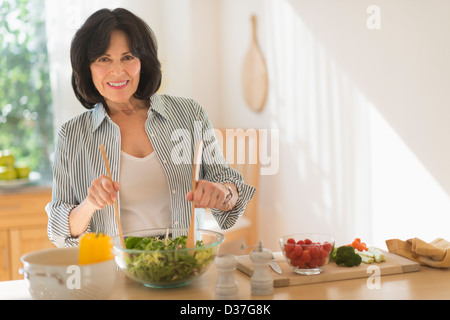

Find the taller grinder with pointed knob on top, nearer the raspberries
[[244, 241, 273, 296]]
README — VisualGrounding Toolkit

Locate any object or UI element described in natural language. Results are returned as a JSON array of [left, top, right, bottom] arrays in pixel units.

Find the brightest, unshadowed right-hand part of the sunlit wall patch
[[370, 107, 450, 243]]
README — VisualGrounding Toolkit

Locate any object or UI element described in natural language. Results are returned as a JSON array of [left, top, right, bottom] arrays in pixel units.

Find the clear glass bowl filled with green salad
[[114, 229, 225, 288]]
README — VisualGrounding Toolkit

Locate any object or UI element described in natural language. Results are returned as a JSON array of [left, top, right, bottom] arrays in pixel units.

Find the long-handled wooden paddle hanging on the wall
[[242, 15, 269, 112]]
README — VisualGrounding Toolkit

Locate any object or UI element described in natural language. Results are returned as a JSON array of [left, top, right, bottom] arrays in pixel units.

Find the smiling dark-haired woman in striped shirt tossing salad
[[46, 9, 255, 247]]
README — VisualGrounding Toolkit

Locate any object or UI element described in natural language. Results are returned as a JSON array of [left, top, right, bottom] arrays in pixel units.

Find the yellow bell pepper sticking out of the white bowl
[[78, 233, 114, 265]]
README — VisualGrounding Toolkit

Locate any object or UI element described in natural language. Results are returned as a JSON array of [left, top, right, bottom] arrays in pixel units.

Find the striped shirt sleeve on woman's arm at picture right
[[199, 102, 256, 229]]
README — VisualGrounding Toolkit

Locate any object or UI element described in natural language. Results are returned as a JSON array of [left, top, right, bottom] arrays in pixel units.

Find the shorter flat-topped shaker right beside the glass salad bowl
[[214, 254, 239, 300]]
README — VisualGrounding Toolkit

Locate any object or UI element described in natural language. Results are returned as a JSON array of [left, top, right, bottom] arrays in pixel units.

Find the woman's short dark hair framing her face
[[70, 8, 161, 109]]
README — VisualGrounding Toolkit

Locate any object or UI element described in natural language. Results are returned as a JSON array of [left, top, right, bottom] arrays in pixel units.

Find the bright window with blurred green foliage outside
[[0, 0, 53, 176]]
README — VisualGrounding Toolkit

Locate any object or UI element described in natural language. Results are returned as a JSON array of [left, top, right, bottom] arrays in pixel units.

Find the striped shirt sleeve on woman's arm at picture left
[[45, 126, 89, 247]]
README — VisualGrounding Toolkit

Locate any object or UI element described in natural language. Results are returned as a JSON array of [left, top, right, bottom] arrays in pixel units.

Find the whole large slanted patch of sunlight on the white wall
[[263, 1, 450, 248]]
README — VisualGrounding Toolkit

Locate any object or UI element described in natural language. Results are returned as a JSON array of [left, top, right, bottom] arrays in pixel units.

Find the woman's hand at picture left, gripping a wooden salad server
[[86, 175, 120, 210]]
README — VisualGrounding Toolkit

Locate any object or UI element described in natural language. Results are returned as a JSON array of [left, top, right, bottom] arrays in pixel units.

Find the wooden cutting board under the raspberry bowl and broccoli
[[237, 250, 420, 288]]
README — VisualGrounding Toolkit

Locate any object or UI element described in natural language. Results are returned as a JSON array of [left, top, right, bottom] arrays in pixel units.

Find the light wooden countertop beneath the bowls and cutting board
[[0, 258, 450, 300]]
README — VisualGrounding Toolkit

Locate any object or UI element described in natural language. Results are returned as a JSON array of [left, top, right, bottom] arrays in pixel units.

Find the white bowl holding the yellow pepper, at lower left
[[19, 248, 117, 300]]
